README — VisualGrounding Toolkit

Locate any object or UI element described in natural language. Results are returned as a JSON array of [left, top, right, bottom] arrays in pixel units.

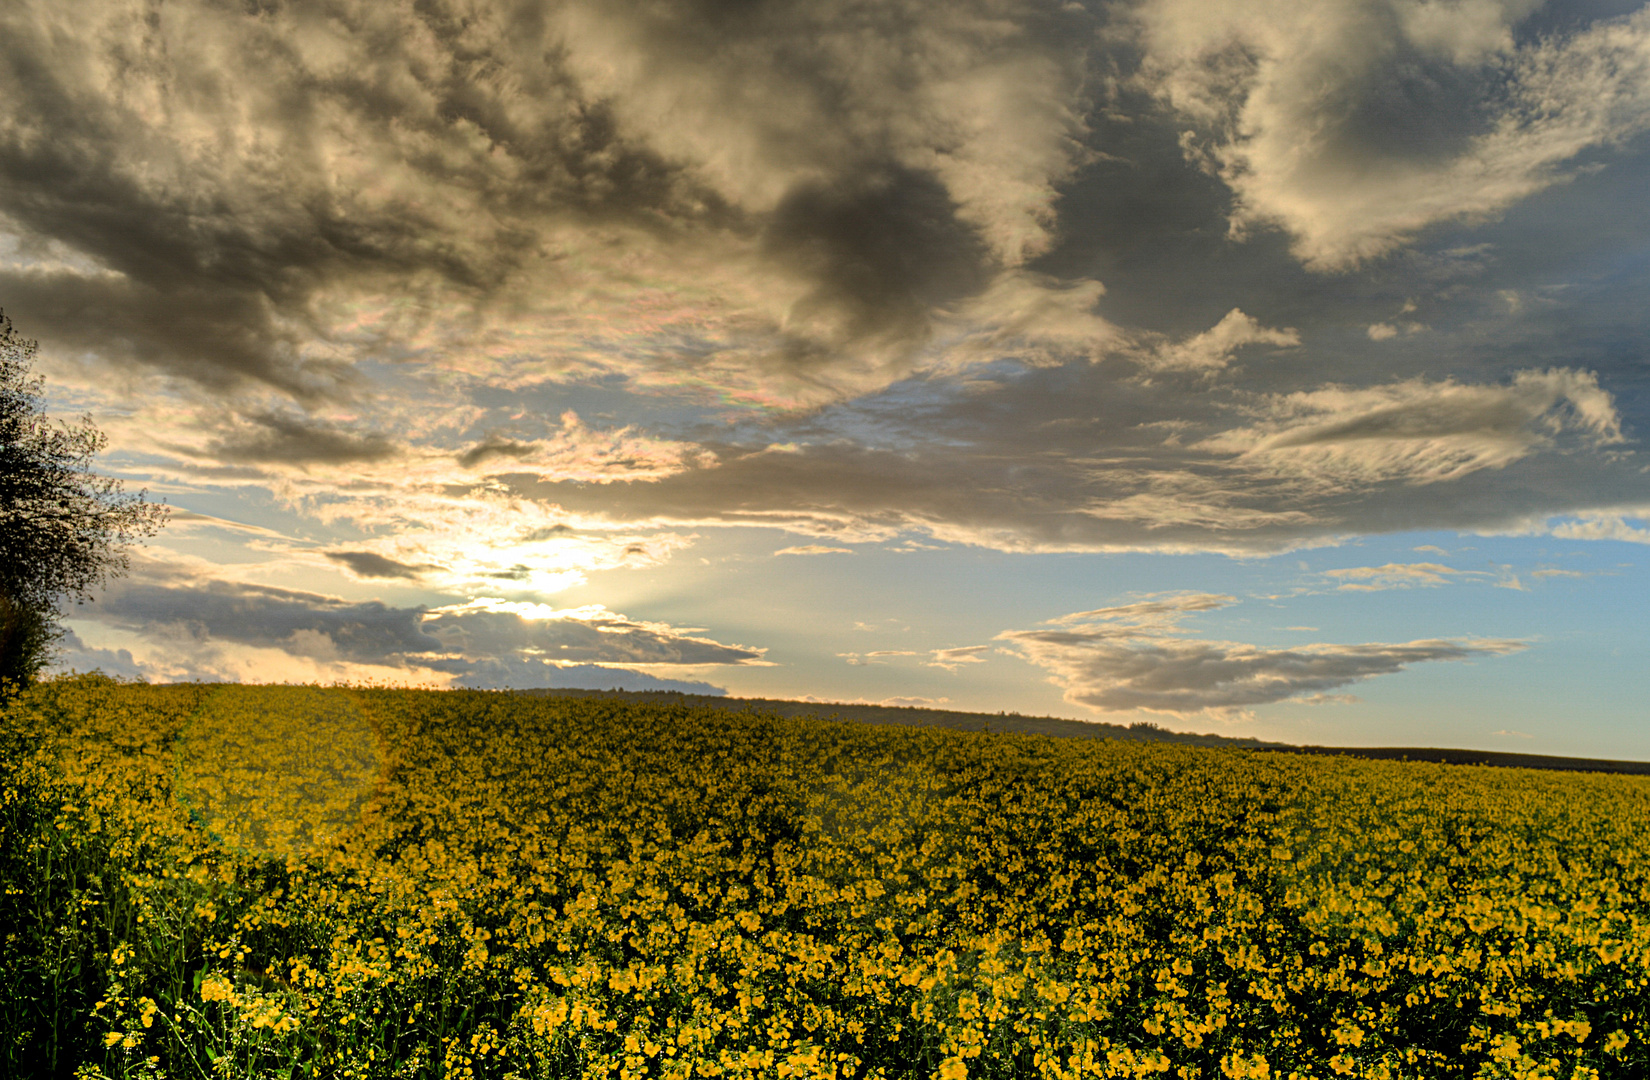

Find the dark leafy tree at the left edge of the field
[[0, 310, 167, 684]]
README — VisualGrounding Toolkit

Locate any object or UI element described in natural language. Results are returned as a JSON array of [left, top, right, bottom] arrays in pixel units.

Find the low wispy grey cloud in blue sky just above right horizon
[[997, 594, 1525, 719]]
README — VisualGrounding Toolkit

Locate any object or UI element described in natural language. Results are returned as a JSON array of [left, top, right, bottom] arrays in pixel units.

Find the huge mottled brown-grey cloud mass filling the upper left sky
[[0, 0, 1094, 406]]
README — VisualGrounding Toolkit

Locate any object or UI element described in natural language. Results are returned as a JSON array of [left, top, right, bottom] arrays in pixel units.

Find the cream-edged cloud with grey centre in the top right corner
[[1135, 0, 1650, 272]]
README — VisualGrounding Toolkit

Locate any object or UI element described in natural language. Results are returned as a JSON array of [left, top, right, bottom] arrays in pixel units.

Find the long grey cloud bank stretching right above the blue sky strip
[[500, 359, 1647, 552]]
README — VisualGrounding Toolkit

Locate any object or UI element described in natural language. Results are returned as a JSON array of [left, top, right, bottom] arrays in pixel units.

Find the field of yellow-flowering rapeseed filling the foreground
[[0, 676, 1650, 1080]]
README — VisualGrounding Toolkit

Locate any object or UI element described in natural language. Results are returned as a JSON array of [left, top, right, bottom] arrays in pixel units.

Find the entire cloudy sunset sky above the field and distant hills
[[0, 0, 1650, 758]]
